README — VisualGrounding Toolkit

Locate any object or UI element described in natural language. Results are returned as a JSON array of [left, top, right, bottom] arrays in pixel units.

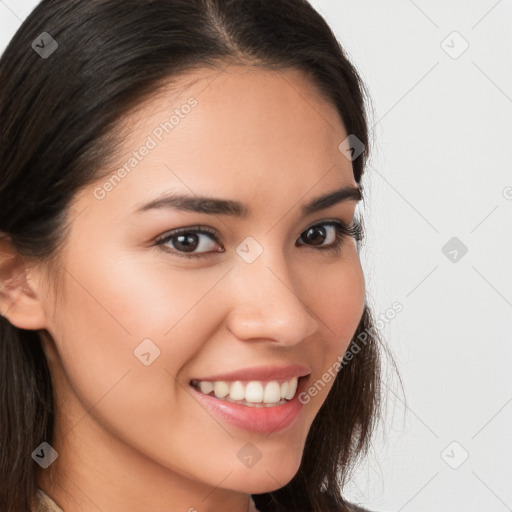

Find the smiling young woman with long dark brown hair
[[0, 0, 380, 512]]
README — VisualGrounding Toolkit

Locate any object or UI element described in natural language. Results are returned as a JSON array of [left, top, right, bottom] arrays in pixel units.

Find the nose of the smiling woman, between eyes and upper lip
[[227, 246, 319, 345]]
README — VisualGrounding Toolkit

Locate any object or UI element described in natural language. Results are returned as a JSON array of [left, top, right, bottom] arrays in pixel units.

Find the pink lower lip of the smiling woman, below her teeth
[[190, 377, 309, 434]]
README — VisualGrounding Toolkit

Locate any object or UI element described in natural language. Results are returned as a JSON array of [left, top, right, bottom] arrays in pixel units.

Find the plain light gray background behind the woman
[[0, 0, 512, 512]]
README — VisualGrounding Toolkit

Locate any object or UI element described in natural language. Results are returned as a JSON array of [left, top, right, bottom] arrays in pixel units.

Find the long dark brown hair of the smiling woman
[[0, 0, 380, 512]]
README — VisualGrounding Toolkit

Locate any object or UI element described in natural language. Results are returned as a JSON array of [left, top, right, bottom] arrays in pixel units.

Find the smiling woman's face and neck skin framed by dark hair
[[35, 67, 364, 511]]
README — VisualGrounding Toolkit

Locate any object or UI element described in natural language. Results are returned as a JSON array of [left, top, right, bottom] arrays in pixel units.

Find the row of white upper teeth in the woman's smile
[[193, 377, 298, 404]]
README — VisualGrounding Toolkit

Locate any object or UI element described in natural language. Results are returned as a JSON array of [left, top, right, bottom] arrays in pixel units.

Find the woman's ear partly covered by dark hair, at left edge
[[0, 237, 47, 330]]
